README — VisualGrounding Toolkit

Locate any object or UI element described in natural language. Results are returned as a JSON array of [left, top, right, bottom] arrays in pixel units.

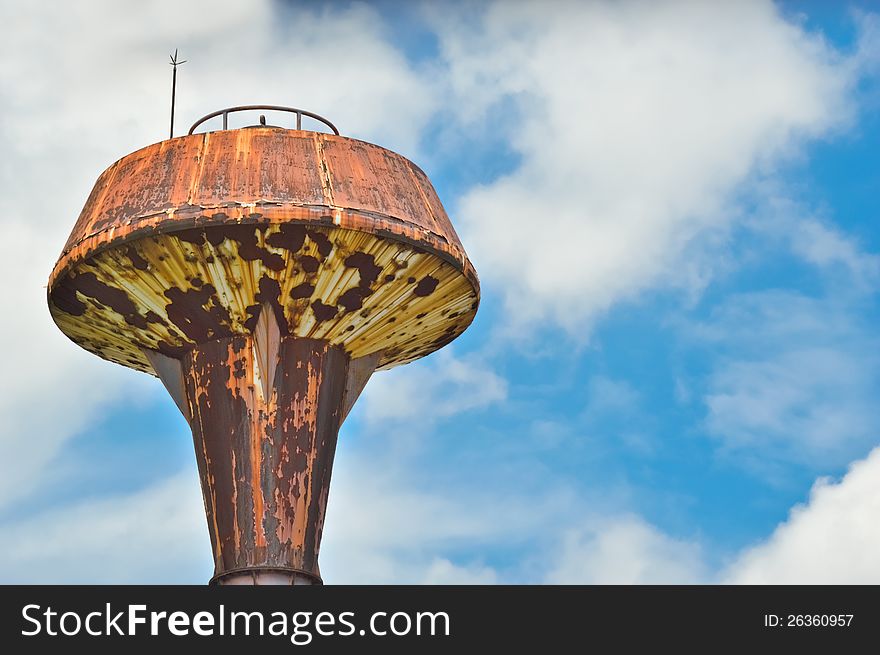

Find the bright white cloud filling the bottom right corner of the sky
[[724, 448, 880, 584]]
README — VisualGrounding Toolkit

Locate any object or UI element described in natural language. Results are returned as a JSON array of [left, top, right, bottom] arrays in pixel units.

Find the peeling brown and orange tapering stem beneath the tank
[[182, 336, 358, 581]]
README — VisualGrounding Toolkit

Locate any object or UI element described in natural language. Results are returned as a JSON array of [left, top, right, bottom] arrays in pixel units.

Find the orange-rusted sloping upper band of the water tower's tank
[[52, 128, 476, 284]]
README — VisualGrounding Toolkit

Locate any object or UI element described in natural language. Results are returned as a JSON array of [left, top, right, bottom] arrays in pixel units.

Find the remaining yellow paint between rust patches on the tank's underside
[[50, 225, 477, 371]]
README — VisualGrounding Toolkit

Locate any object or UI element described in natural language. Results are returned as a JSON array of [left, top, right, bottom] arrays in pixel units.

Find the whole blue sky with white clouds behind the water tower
[[0, 1, 880, 583]]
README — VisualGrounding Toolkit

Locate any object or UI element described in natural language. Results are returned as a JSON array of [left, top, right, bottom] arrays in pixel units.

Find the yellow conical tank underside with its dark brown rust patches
[[51, 222, 476, 372]]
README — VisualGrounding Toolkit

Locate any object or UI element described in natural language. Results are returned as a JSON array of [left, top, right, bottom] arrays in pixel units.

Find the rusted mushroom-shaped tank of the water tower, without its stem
[[50, 128, 479, 371]]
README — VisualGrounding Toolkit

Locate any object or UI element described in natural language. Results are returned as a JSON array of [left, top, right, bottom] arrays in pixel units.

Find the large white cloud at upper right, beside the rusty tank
[[435, 2, 873, 338]]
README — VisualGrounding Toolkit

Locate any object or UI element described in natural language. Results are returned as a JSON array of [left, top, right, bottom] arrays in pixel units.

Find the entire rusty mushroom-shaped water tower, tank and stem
[[48, 106, 479, 584]]
